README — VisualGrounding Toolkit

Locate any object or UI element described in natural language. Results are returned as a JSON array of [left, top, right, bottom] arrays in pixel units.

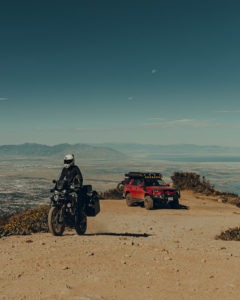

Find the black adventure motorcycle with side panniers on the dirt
[[48, 180, 100, 236]]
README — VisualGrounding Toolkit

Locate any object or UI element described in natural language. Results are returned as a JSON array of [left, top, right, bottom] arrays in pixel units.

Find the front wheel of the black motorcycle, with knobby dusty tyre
[[48, 206, 65, 236]]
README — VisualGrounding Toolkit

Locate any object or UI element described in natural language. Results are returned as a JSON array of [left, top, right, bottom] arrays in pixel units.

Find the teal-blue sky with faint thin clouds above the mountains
[[0, 0, 240, 146]]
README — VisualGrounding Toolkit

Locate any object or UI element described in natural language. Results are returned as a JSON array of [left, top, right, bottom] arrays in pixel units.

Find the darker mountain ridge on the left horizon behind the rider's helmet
[[0, 143, 127, 160]]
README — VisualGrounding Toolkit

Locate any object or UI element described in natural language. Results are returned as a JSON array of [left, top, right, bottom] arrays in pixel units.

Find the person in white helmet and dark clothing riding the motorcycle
[[58, 154, 86, 211]]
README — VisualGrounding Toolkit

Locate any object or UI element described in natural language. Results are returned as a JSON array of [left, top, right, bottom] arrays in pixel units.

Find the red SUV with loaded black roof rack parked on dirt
[[117, 172, 180, 209]]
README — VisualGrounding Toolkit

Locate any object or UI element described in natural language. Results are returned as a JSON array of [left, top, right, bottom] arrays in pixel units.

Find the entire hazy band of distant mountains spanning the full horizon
[[0, 143, 240, 162]]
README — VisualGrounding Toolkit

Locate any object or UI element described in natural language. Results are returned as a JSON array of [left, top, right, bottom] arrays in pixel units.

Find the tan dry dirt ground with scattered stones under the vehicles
[[0, 192, 240, 300]]
